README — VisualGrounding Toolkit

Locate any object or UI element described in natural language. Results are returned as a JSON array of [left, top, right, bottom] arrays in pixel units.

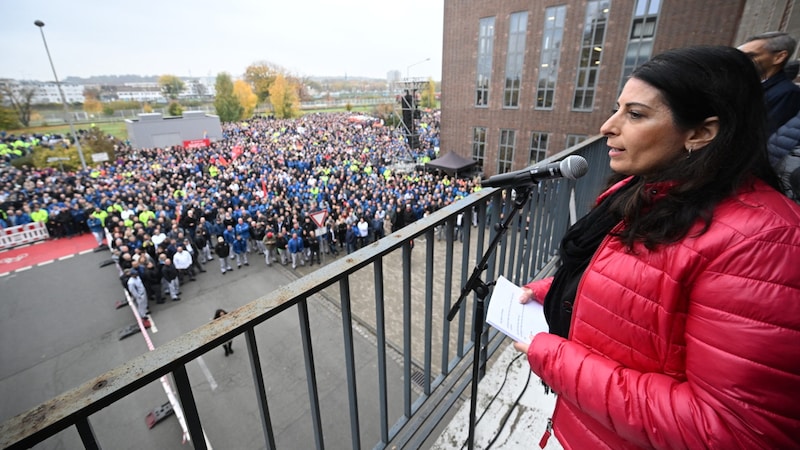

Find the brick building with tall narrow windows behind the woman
[[441, 0, 800, 176]]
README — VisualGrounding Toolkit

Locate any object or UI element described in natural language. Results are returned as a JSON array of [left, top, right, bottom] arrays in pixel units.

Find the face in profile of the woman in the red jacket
[[600, 78, 691, 176]]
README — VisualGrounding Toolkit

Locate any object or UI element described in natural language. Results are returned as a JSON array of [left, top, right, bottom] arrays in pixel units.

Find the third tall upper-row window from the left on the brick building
[[536, 5, 567, 109]]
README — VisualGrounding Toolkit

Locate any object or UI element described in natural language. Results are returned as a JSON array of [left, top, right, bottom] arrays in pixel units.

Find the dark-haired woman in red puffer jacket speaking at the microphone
[[515, 47, 800, 450]]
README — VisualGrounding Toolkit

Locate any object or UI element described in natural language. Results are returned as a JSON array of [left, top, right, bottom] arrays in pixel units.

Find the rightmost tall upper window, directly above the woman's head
[[619, 0, 661, 91]]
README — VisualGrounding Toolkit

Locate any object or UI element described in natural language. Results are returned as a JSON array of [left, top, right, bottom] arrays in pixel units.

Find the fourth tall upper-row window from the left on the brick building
[[572, 0, 610, 111]]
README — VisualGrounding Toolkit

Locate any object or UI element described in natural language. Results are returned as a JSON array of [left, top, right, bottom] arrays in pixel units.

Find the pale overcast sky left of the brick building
[[0, 0, 444, 81]]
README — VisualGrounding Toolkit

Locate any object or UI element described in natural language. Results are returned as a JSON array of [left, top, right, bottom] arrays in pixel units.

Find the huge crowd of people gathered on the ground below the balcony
[[0, 111, 479, 317]]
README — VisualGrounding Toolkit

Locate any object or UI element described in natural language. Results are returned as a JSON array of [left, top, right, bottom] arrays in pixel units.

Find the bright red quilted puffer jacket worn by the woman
[[528, 181, 800, 450]]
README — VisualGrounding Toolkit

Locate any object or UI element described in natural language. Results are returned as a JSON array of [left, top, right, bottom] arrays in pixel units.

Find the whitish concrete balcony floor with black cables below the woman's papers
[[432, 339, 563, 450]]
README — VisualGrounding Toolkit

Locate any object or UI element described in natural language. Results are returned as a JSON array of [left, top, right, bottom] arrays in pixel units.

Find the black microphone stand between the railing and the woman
[[447, 184, 532, 450]]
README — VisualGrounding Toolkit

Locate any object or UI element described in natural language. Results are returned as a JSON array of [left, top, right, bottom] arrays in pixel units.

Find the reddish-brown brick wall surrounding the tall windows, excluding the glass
[[441, 0, 745, 176]]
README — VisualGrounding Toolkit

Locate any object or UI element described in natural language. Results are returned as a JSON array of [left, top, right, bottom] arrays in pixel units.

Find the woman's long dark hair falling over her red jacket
[[612, 46, 779, 249]]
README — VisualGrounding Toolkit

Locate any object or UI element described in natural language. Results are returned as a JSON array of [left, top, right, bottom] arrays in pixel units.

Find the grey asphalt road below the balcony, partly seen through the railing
[[0, 248, 402, 449]]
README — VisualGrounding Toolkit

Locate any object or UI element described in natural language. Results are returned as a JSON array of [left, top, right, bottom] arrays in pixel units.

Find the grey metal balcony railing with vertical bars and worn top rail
[[0, 137, 609, 449]]
